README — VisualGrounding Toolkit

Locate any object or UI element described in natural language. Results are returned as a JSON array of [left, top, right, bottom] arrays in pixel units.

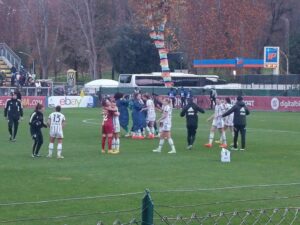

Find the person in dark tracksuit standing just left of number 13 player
[[29, 104, 47, 158]]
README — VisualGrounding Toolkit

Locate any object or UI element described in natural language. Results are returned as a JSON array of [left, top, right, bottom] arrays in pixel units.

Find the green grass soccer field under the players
[[0, 109, 300, 225]]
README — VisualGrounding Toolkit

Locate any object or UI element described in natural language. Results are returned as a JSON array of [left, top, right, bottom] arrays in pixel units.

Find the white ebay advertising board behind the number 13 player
[[48, 96, 94, 108]]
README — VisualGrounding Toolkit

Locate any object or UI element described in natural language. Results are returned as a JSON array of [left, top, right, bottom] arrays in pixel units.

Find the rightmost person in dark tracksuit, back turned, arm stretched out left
[[222, 96, 250, 151]]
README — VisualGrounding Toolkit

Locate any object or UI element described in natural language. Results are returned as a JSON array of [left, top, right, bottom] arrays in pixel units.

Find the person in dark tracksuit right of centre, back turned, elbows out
[[180, 98, 205, 150]]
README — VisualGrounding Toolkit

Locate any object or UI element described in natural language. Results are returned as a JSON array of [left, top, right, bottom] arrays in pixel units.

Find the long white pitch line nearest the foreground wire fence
[[0, 183, 300, 206]]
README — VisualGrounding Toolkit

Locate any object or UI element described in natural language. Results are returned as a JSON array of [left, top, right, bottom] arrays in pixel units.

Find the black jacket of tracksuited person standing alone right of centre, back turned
[[180, 102, 205, 127]]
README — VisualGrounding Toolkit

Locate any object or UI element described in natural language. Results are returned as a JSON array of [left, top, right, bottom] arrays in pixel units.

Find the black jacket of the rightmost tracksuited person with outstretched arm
[[222, 101, 250, 126]]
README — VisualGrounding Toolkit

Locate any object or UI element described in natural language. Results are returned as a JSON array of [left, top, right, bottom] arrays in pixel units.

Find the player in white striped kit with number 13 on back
[[47, 106, 66, 159]]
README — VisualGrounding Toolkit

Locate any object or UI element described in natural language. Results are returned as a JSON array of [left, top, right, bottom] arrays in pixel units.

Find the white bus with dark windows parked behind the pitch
[[119, 73, 225, 87]]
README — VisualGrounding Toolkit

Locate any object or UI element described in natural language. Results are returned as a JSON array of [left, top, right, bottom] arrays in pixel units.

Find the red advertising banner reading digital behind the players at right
[[159, 95, 300, 112]]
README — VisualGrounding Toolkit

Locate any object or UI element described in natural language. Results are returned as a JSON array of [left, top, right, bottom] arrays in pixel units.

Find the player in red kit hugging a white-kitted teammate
[[102, 99, 117, 153]]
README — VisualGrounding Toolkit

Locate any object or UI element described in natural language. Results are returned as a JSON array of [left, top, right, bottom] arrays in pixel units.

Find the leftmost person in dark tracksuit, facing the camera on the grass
[[4, 92, 23, 142]]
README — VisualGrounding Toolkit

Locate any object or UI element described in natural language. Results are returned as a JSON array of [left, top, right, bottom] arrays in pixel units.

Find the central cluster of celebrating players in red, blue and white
[[102, 93, 176, 154]]
